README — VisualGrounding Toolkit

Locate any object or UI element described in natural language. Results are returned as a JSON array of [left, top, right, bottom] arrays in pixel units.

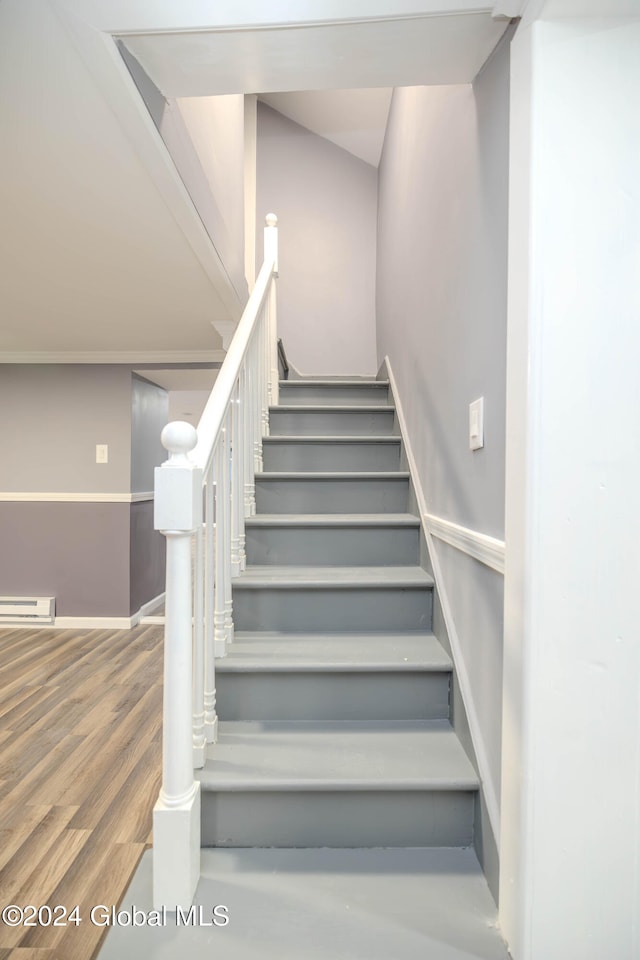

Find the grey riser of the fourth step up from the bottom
[[245, 524, 419, 566]]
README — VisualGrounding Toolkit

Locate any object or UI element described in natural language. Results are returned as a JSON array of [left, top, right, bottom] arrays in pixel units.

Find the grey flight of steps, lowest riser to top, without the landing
[[199, 380, 478, 848]]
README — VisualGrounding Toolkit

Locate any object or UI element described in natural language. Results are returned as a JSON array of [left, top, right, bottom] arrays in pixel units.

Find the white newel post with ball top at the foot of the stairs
[[153, 421, 202, 910]]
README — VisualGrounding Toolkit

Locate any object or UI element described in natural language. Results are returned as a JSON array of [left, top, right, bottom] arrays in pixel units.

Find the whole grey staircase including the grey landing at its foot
[[100, 380, 508, 960]]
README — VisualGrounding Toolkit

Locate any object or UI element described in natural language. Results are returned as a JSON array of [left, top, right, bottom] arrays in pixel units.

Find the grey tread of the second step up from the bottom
[[216, 632, 452, 673]]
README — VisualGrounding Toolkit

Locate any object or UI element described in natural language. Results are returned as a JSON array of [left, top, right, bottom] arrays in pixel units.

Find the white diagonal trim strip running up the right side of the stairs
[[384, 357, 500, 851]]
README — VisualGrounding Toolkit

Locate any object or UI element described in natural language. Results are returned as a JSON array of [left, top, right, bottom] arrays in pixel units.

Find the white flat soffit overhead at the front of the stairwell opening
[[125, 10, 508, 97]]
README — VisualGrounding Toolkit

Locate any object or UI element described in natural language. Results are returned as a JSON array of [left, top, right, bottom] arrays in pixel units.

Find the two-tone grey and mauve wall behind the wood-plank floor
[[0, 364, 168, 617]]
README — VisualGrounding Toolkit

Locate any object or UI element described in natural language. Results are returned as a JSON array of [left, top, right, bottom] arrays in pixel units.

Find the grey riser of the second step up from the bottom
[[216, 670, 450, 722]]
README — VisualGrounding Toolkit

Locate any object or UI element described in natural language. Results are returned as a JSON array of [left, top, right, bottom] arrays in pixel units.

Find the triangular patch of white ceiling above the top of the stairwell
[[259, 87, 393, 167]]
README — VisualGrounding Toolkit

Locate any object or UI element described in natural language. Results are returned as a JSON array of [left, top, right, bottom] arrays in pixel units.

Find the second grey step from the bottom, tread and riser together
[[216, 633, 451, 721]]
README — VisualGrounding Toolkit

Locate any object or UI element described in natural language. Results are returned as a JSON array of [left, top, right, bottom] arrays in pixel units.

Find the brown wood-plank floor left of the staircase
[[0, 626, 163, 960]]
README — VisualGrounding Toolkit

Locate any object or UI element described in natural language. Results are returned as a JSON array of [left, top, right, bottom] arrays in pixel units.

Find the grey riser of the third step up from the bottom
[[233, 585, 431, 633]]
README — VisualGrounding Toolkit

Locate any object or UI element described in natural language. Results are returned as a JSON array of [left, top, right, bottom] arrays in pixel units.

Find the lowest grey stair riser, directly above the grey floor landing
[[202, 790, 474, 847]]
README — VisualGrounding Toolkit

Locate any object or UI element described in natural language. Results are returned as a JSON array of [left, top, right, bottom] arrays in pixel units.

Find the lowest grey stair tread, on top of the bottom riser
[[199, 720, 478, 791]]
